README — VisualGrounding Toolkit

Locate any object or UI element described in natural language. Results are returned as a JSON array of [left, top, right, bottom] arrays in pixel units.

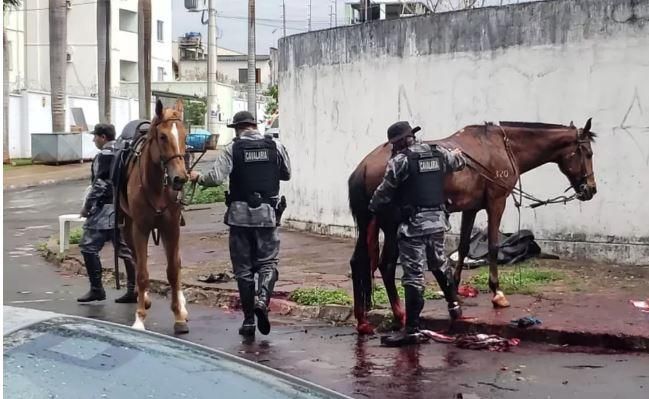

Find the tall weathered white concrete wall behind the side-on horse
[[279, 0, 649, 264]]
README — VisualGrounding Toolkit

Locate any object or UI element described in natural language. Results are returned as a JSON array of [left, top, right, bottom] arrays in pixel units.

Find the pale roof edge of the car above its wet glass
[[3, 305, 350, 399]]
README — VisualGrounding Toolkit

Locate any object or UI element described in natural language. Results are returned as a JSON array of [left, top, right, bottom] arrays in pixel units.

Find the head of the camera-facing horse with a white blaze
[[150, 99, 189, 191]]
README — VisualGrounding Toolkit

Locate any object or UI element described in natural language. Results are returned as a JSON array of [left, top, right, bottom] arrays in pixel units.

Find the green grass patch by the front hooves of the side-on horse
[[469, 262, 564, 294]]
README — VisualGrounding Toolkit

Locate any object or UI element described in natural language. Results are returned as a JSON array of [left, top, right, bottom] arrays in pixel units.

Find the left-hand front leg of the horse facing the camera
[[131, 222, 151, 330]]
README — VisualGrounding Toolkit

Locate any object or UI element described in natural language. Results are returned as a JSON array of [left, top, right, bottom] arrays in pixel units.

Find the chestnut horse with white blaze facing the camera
[[120, 100, 189, 334]]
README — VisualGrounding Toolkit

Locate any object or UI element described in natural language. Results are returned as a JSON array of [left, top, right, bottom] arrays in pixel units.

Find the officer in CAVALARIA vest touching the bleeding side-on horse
[[369, 122, 466, 346]]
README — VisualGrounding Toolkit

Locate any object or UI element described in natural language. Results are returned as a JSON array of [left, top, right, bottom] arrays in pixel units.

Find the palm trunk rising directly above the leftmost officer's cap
[[97, 0, 112, 123]]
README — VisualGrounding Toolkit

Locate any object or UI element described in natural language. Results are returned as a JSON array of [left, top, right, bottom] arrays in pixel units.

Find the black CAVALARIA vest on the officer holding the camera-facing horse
[[230, 138, 279, 201]]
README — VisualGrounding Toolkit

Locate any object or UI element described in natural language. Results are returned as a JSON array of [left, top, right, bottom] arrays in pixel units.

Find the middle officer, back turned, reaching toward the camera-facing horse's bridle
[[190, 111, 291, 337]]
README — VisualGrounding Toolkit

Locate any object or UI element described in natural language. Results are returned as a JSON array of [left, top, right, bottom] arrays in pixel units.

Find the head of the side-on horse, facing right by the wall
[[558, 119, 597, 201]]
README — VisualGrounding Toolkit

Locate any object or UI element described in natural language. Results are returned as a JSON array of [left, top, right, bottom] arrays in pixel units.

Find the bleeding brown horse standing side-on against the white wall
[[348, 119, 597, 333]]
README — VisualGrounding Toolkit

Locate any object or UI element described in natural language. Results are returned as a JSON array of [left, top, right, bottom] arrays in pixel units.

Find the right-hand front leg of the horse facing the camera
[[160, 219, 189, 334]]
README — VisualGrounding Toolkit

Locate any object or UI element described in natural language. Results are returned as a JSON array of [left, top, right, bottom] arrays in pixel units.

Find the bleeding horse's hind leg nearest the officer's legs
[[379, 223, 406, 327]]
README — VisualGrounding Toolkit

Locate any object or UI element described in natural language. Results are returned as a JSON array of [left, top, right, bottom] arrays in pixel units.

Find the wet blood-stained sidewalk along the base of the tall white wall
[[41, 204, 649, 351]]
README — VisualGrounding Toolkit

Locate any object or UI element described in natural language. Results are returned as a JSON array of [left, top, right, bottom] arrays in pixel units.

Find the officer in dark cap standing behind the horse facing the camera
[[77, 123, 137, 303]]
